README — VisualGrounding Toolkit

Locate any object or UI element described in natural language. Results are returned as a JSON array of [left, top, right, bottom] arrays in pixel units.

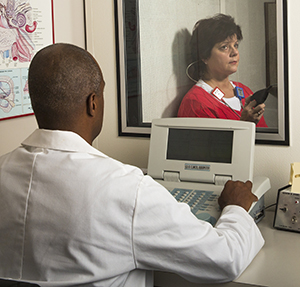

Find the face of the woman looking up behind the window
[[203, 35, 240, 80]]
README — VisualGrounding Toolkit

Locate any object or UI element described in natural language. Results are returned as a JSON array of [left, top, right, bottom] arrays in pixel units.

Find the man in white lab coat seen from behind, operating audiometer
[[0, 44, 264, 287]]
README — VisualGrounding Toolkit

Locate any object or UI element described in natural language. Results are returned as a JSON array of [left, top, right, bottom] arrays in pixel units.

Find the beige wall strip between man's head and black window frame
[[86, 0, 149, 167]]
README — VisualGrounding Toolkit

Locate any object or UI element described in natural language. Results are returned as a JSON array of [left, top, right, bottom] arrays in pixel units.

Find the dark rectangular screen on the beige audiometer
[[167, 128, 233, 163]]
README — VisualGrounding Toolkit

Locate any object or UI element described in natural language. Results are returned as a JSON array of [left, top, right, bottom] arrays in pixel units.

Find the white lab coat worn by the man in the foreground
[[0, 130, 264, 286]]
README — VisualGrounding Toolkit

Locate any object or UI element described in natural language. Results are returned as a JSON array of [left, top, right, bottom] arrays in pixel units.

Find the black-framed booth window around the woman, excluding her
[[115, 0, 289, 145]]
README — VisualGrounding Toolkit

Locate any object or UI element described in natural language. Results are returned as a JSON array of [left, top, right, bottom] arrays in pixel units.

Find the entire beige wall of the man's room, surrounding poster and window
[[0, 0, 300, 209]]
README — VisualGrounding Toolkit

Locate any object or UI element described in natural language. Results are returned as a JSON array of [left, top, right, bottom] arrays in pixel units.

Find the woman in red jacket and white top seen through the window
[[178, 14, 267, 127]]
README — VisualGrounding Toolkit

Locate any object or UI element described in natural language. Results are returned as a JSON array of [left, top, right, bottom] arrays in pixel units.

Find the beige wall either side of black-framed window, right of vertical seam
[[87, 0, 300, 208]]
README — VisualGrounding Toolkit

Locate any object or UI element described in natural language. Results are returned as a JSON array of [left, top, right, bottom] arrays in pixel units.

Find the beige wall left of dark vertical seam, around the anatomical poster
[[0, 0, 85, 155]]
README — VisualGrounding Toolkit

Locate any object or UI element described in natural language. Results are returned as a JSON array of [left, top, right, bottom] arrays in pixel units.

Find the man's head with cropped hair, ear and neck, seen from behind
[[28, 44, 104, 143]]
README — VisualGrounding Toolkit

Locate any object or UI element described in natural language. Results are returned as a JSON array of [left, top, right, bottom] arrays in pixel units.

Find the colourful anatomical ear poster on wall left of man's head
[[0, 0, 54, 120]]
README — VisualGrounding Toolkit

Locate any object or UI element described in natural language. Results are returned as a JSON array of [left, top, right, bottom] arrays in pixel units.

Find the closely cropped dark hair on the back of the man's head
[[28, 43, 103, 126]]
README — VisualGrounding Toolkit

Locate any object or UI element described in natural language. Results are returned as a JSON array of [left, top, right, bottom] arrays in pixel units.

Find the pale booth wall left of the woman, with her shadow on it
[[138, 0, 220, 122]]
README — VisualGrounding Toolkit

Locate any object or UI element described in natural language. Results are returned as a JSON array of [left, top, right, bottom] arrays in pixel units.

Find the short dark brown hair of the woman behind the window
[[191, 14, 243, 80]]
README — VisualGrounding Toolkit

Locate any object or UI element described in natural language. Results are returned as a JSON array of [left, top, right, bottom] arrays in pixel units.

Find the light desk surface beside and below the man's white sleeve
[[154, 211, 300, 287]]
